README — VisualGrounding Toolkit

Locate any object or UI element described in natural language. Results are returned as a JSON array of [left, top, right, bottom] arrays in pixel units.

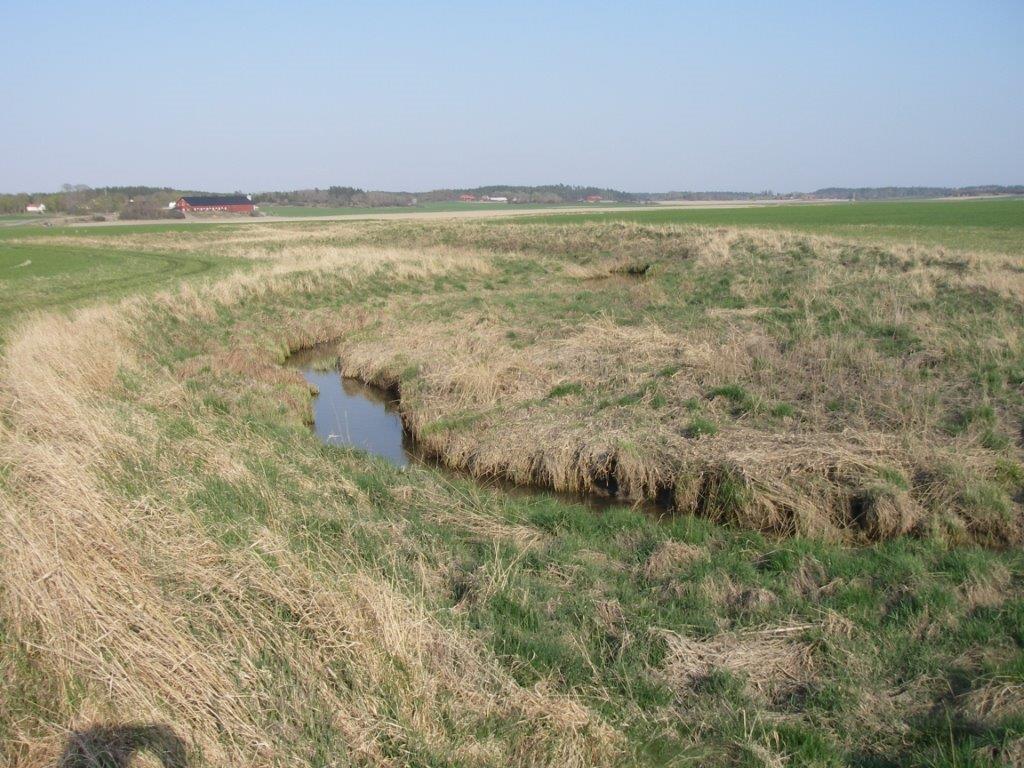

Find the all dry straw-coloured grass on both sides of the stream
[[0, 219, 1024, 766]]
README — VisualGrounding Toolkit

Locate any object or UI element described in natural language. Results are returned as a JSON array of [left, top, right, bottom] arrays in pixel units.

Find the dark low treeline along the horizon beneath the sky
[[0, 184, 1024, 218]]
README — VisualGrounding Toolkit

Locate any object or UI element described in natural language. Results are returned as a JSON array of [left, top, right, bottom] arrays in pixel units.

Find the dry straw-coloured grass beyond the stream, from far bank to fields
[[51, 222, 1011, 542]]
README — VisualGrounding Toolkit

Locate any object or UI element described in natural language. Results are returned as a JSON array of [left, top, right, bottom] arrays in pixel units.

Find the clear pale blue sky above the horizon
[[0, 0, 1024, 191]]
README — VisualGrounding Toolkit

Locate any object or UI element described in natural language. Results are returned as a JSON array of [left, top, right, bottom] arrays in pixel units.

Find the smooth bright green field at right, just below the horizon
[[516, 198, 1024, 254]]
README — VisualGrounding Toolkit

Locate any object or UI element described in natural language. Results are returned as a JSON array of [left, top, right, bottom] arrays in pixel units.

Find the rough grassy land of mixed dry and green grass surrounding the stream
[[0, 207, 1024, 766]]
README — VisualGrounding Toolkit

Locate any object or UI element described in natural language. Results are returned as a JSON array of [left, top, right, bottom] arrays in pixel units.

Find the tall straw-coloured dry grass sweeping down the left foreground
[[0, 264, 616, 766]]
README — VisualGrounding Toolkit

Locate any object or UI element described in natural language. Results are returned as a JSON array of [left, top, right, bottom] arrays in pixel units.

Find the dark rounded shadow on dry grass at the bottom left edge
[[57, 723, 188, 768]]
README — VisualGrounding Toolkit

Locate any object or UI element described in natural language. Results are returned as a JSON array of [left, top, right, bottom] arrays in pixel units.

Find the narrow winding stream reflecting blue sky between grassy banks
[[285, 347, 667, 516]]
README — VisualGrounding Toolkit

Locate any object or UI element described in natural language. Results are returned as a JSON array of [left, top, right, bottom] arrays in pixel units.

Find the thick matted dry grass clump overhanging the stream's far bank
[[339, 307, 1020, 543]]
